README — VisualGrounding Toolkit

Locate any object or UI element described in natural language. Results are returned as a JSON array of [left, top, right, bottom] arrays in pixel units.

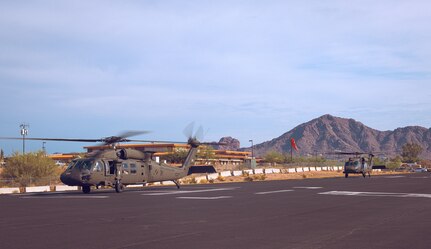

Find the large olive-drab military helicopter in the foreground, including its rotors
[[0, 125, 220, 194]]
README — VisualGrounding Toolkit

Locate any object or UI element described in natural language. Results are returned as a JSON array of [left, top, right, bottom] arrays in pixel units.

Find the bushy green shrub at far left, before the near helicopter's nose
[[2, 151, 59, 187]]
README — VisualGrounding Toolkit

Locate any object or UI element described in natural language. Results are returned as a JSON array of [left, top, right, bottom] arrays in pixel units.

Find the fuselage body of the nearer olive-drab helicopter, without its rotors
[[60, 148, 197, 192]]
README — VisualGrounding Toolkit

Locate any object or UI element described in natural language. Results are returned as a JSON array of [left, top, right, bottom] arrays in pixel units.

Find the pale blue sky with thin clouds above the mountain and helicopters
[[0, 0, 431, 154]]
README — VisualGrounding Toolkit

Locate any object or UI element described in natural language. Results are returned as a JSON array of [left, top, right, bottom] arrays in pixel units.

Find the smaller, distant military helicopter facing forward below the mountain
[[331, 152, 374, 178]]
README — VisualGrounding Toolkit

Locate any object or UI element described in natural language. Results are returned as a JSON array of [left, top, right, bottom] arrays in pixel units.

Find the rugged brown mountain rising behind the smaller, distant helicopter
[[245, 114, 431, 159]]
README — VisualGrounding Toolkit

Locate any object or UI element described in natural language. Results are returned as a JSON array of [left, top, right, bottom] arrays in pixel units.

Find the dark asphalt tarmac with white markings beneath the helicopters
[[0, 173, 431, 249]]
